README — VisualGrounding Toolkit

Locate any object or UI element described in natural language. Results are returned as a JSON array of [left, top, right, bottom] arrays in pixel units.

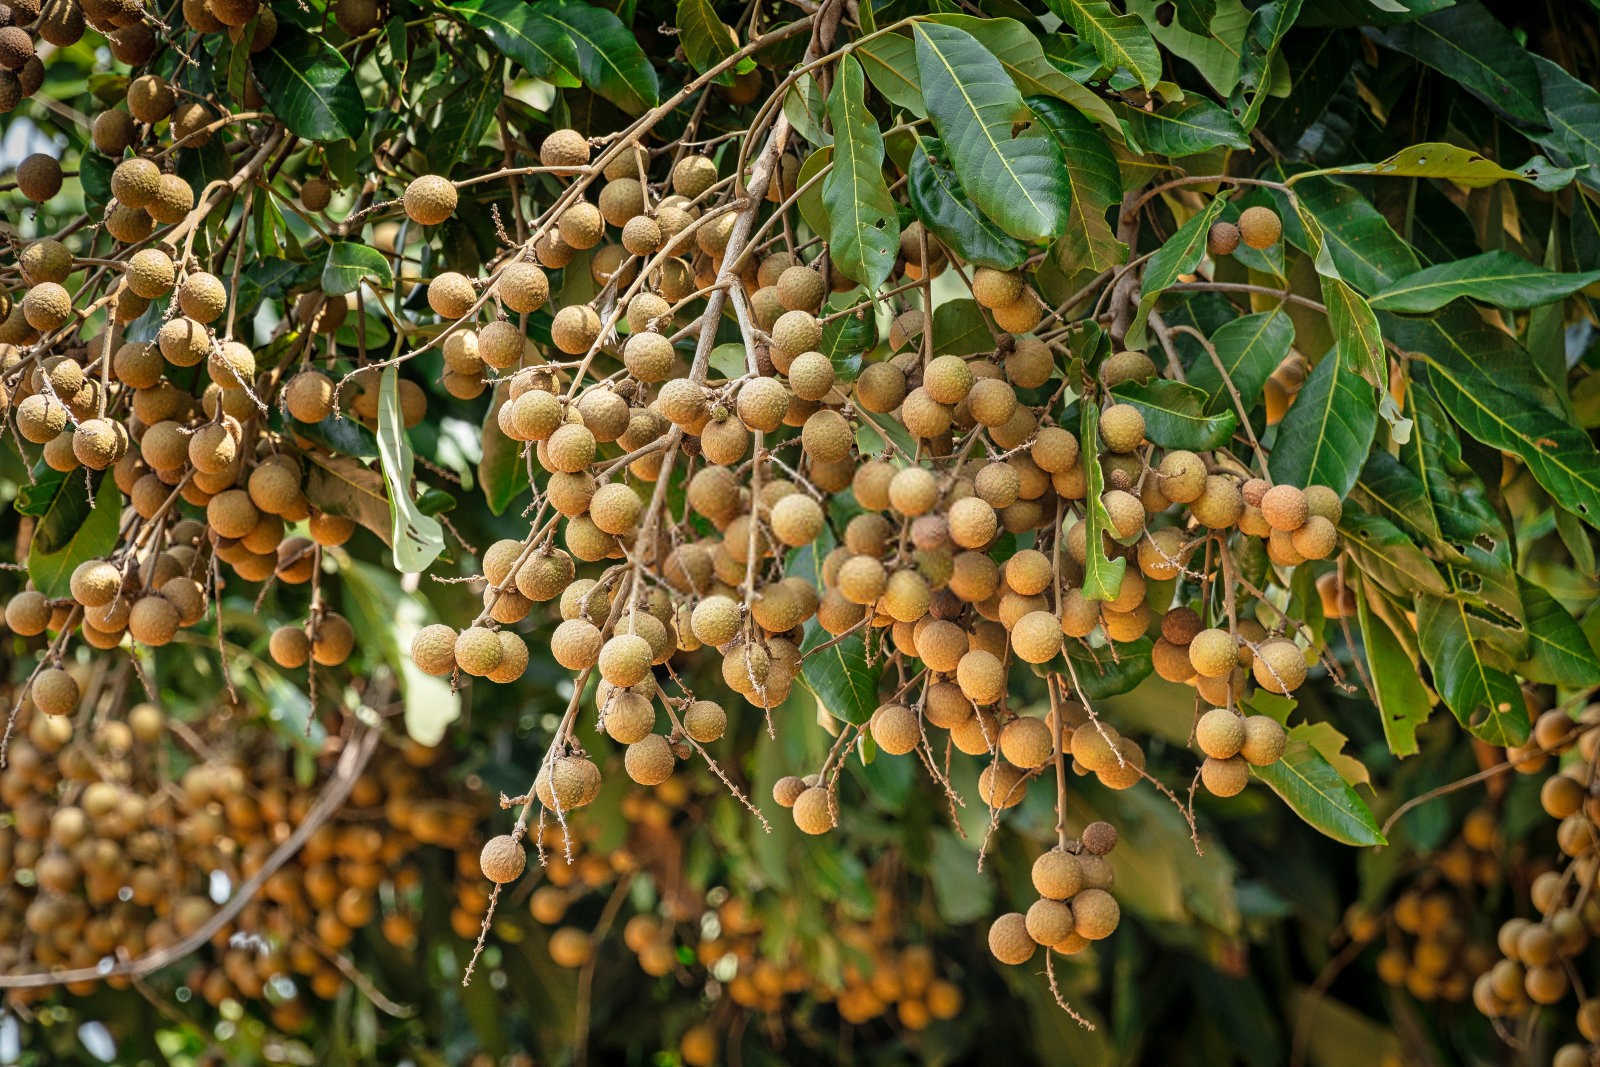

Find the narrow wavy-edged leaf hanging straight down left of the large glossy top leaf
[[822, 56, 899, 291]]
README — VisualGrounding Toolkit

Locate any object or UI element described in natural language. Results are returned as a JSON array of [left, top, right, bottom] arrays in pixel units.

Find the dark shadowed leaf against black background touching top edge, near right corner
[[1378, 0, 1546, 126]]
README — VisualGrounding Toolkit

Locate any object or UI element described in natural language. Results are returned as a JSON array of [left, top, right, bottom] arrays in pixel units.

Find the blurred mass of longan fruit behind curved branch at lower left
[[0, 694, 485, 1030]]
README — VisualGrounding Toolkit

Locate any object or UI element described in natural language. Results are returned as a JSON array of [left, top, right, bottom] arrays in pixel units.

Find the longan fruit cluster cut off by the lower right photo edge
[[1472, 704, 1600, 1067]]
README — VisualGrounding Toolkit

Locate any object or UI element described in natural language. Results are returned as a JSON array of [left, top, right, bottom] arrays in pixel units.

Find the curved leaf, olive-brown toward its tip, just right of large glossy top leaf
[[1024, 96, 1128, 274]]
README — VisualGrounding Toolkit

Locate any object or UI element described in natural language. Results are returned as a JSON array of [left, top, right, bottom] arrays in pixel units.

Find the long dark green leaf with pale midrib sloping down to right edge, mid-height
[[1389, 312, 1600, 526]]
